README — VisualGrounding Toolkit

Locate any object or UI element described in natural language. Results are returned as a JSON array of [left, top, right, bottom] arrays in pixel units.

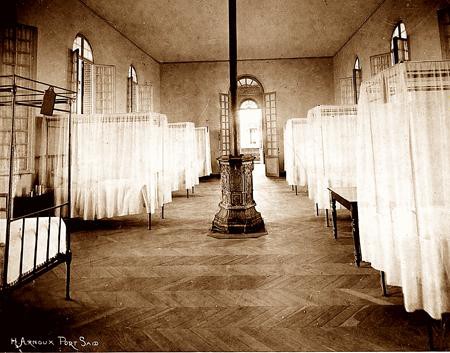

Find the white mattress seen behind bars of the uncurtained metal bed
[[0, 217, 66, 283]]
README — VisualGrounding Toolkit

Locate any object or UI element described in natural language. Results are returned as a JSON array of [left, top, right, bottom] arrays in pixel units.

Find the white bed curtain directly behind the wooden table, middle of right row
[[307, 105, 357, 209]]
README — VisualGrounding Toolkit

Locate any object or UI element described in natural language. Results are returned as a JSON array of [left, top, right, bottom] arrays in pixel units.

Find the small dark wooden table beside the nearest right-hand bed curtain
[[328, 187, 362, 267]]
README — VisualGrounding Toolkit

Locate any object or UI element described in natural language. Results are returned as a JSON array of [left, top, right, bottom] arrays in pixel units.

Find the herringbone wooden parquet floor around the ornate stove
[[0, 168, 436, 351]]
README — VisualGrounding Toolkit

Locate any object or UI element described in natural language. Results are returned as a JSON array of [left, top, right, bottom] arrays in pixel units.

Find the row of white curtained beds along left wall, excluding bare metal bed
[[51, 113, 211, 220]]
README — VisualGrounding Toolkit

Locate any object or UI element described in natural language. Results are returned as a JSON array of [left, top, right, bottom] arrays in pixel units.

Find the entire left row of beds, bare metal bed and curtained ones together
[[0, 75, 211, 299]]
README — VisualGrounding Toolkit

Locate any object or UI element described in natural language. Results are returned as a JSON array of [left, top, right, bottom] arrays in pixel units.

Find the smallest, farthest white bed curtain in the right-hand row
[[284, 118, 309, 186]]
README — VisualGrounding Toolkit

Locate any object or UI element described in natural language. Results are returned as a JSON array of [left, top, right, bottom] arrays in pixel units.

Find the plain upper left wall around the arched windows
[[17, 0, 160, 112]]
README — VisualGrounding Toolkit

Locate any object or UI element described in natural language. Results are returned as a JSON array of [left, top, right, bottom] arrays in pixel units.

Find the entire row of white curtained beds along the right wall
[[285, 61, 450, 319]]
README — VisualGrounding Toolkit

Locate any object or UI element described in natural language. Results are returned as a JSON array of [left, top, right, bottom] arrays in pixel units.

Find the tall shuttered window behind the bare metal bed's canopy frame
[[0, 24, 37, 174]]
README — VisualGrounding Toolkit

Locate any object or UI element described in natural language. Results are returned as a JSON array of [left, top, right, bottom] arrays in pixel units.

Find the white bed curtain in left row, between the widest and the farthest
[[165, 122, 199, 191]]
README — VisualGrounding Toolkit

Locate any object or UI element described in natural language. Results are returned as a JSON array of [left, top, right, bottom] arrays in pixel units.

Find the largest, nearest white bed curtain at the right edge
[[358, 61, 450, 319]]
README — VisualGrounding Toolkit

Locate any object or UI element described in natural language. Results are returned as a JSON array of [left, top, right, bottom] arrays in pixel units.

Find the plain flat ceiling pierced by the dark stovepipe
[[81, 0, 383, 62]]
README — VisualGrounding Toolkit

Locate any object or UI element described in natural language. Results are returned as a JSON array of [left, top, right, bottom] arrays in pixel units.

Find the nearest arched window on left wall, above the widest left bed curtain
[[72, 34, 94, 114]]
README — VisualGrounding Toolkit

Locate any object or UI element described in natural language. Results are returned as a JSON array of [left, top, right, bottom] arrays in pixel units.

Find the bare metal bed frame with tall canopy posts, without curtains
[[0, 75, 76, 300]]
